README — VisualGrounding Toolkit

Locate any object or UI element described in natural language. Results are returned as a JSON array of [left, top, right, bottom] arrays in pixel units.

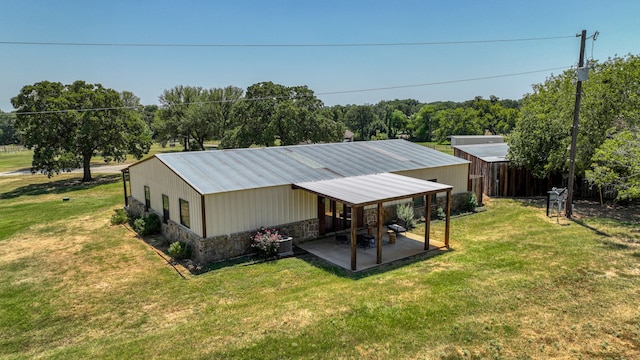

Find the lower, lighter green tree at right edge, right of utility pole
[[585, 129, 640, 200]]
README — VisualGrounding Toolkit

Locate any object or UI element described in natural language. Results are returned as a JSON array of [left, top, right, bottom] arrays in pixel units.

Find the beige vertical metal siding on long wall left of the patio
[[205, 185, 317, 236]]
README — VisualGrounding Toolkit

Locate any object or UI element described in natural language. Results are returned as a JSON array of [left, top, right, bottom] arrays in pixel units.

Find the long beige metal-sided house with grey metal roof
[[123, 140, 469, 262]]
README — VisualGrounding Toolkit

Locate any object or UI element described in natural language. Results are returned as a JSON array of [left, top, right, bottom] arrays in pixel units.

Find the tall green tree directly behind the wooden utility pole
[[508, 55, 640, 178]]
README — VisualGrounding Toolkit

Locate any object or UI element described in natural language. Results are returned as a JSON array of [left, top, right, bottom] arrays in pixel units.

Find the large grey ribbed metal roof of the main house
[[142, 140, 468, 194]]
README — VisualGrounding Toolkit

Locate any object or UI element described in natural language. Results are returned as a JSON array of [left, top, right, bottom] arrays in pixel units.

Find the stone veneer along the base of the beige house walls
[[128, 197, 320, 264]]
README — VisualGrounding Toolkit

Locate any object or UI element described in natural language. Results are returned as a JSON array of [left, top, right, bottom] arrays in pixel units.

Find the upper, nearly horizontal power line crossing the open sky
[[0, 35, 575, 48]]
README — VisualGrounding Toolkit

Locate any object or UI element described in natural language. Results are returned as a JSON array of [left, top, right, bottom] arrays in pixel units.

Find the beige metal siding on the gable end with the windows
[[129, 158, 202, 236]]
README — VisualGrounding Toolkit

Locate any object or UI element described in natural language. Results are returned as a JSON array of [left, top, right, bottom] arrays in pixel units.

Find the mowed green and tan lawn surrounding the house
[[0, 175, 640, 359]]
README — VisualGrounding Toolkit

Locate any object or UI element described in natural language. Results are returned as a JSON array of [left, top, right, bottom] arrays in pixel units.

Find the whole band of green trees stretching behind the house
[[6, 55, 640, 200]]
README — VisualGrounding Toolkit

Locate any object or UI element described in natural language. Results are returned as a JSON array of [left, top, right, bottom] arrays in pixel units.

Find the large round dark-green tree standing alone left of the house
[[11, 81, 151, 181]]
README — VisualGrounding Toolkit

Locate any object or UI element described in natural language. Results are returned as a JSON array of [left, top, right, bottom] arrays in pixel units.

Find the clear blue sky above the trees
[[0, 0, 640, 111]]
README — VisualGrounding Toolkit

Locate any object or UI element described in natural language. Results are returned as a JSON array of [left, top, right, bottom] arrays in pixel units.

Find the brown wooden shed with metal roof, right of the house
[[453, 142, 562, 197]]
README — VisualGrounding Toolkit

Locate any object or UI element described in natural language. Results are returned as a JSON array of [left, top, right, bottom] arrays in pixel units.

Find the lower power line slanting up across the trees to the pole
[[12, 66, 571, 115]]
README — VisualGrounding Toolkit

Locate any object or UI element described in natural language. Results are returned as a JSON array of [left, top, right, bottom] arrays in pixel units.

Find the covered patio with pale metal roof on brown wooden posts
[[292, 173, 453, 271]]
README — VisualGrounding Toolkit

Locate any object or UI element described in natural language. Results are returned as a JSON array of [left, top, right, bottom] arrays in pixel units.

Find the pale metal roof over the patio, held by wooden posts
[[293, 173, 453, 206]]
